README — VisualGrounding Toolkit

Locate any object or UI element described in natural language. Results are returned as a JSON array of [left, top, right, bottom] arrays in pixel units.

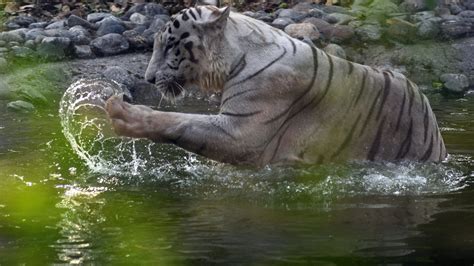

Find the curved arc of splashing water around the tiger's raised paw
[[59, 79, 174, 176]]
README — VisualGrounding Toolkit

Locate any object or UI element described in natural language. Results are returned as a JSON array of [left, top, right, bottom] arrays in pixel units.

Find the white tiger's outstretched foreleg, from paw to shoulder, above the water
[[106, 93, 259, 164]]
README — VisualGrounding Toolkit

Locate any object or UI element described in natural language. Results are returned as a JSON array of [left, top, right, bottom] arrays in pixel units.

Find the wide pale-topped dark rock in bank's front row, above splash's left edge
[[37, 37, 71, 59]]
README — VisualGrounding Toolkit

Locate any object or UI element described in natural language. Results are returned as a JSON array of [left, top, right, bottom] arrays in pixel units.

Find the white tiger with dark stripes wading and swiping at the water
[[107, 6, 447, 166]]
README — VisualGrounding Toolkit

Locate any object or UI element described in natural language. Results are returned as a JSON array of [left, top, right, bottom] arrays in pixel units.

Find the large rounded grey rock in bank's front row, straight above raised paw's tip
[[91, 33, 129, 55]]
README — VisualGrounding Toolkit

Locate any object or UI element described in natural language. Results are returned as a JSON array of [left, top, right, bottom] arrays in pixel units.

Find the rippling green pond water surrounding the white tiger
[[0, 77, 474, 265]]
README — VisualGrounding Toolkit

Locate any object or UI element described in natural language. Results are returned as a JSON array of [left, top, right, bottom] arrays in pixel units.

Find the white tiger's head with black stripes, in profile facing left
[[145, 6, 230, 98]]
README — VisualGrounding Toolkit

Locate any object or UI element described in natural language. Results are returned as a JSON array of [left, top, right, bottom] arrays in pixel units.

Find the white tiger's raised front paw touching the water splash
[[105, 95, 149, 138]]
